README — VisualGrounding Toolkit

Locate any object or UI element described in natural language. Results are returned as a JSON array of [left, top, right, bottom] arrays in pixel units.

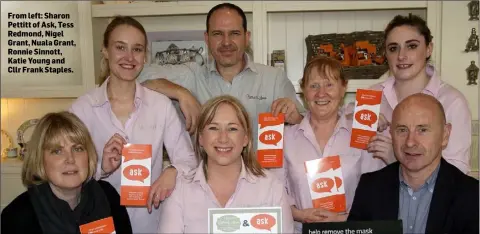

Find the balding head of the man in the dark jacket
[[390, 98, 451, 172]]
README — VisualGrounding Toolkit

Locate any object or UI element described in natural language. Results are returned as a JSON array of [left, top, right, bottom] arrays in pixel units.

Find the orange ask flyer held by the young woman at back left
[[120, 144, 152, 206]]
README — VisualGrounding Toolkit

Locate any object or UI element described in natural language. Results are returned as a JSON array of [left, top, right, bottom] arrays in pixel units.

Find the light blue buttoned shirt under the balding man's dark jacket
[[398, 165, 440, 233]]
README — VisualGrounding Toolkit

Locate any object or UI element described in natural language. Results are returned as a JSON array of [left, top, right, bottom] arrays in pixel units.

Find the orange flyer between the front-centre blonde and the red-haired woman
[[257, 113, 285, 168]]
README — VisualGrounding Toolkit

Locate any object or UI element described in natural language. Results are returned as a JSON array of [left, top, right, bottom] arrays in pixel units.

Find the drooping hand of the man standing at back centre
[[178, 89, 201, 134]]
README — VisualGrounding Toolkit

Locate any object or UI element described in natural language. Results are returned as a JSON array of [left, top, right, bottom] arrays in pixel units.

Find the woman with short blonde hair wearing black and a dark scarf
[[1, 112, 132, 234]]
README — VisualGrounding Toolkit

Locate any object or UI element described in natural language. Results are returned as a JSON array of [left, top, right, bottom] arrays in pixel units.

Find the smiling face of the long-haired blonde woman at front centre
[[199, 103, 248, 166]]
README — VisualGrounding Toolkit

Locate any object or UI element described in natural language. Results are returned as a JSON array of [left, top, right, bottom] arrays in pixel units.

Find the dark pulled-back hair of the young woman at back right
[[384, 14, 433, 61]]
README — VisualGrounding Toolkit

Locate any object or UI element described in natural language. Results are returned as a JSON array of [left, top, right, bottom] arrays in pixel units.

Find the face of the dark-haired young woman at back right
[[385, 25, 433, 80]]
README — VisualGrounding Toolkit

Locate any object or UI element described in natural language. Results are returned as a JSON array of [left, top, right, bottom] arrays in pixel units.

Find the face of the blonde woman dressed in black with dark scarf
[[43, 137, 89, 190]]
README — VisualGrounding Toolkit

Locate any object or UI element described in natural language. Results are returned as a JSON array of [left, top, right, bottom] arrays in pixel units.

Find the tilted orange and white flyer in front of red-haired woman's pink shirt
[[305, 155, 347, 212]]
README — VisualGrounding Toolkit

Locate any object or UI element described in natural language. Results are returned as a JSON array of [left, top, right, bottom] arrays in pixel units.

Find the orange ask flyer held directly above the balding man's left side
[[350, 89, 382, 149]]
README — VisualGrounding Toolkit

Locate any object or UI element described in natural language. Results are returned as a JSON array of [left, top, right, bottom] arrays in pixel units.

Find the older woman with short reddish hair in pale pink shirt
[[284, 56, 389, 232]]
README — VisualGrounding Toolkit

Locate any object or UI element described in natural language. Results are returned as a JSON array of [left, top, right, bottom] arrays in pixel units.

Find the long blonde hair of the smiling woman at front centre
[[193, 95, 265, 177]]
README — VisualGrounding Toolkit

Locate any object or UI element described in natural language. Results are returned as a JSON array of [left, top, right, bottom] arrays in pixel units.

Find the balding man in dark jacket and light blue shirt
[[348, 94, 479, 233]]
